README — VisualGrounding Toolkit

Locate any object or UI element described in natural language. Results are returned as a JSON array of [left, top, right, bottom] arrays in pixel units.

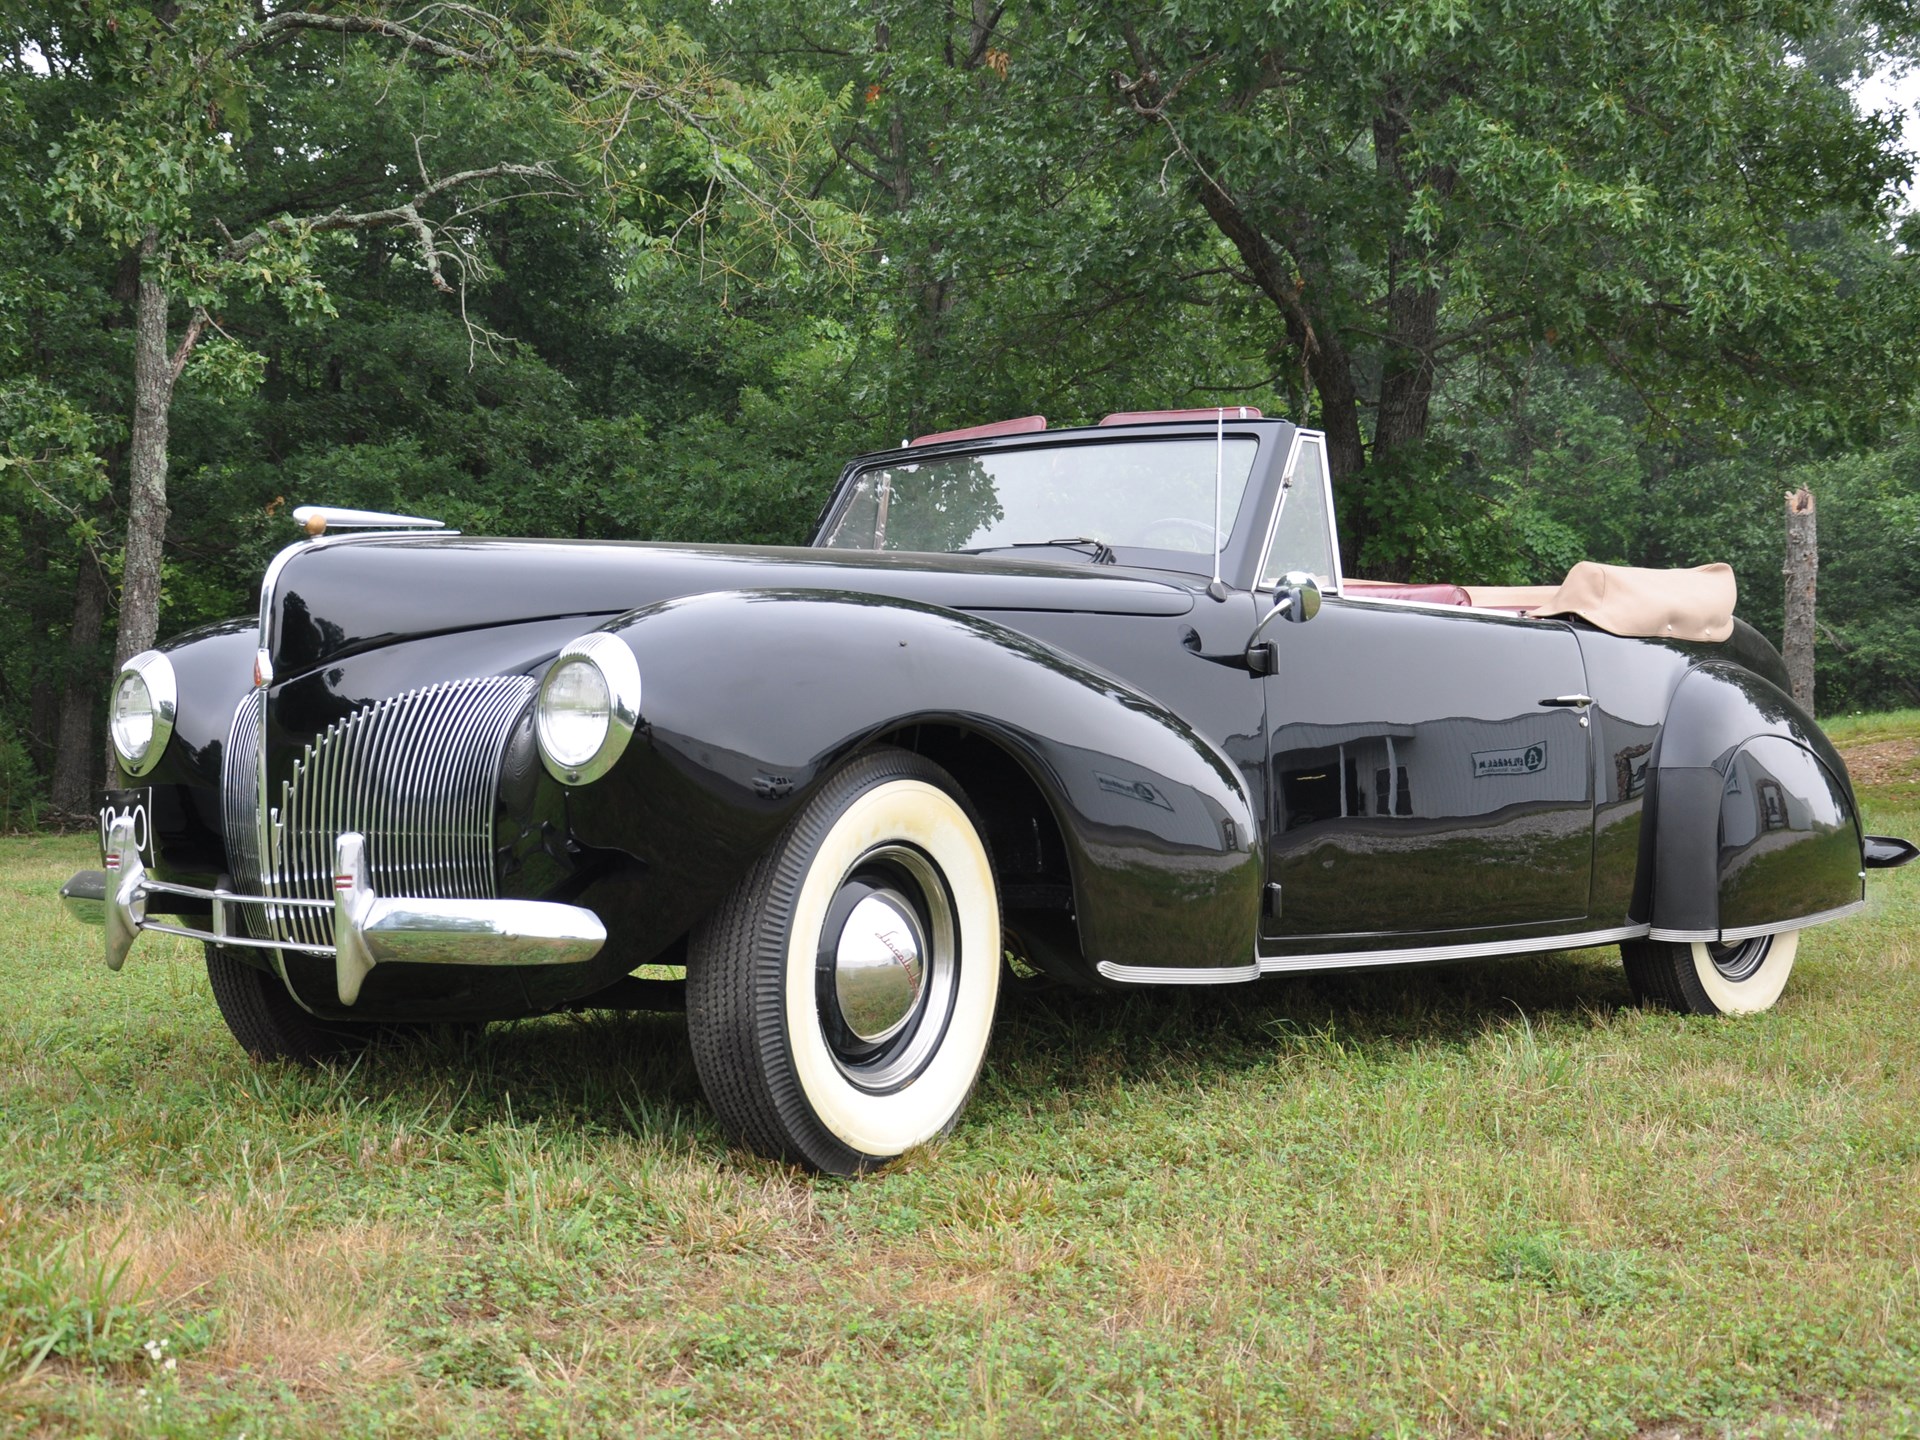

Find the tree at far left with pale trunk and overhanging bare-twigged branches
[[33, 0, 839, 672]]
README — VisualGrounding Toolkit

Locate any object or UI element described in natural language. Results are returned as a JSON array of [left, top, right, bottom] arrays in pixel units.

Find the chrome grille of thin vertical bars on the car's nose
[[227, 676, 534, 945]]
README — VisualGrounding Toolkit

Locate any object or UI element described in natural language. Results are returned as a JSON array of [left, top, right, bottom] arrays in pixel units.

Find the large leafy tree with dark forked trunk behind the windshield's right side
[[1082, 0, 1920, 574]]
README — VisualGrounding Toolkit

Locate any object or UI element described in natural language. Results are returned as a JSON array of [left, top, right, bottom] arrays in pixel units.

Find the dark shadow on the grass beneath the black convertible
[[311, 950, 1630, 1152]]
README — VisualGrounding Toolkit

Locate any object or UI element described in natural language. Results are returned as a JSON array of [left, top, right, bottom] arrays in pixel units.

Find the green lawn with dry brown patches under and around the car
[[0, 744, 1920, 1440]]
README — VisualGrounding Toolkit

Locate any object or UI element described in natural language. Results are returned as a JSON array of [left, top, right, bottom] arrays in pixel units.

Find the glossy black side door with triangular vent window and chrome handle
[[1263, 436, 1594, 952]]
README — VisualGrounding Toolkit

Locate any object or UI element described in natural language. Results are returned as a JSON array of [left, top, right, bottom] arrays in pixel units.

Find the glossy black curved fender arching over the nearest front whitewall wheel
[[568, 591, 1260, 968]]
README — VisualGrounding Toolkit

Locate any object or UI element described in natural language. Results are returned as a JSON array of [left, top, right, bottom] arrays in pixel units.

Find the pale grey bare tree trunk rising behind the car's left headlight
[[113, 236, 184, 664]]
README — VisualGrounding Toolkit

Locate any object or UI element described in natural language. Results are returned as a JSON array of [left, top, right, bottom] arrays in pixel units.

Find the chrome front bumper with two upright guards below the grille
[[60, 816, 607, 1004]]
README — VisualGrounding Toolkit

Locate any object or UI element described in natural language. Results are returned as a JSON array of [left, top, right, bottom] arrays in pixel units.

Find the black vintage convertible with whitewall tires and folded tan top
[[65, 411, 1914, 1173]]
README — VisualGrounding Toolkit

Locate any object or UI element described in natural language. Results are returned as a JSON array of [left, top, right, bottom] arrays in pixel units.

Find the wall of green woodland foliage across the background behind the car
[[0, 0, 1920, 794]]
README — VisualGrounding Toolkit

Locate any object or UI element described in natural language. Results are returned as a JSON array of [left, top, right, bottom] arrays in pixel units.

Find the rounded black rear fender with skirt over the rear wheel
[[1649, 664, 1864, 941]]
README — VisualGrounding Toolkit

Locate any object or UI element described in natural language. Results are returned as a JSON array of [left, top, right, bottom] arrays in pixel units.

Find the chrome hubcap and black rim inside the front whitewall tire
[[816, 845, 960, 1094]]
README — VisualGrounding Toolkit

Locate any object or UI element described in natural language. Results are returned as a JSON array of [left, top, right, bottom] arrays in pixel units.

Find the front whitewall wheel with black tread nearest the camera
[[687, 749, 1000, 1175]]
